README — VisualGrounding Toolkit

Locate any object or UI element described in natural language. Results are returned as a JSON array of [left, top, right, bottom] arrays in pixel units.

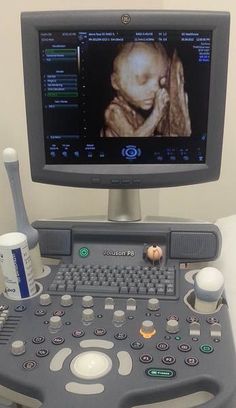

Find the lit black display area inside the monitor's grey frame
[[39, 31, 211, 164]]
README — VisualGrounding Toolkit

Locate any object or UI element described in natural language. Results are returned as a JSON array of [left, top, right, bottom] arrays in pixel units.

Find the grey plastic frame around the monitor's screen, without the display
[[21, 10, 230, 189]]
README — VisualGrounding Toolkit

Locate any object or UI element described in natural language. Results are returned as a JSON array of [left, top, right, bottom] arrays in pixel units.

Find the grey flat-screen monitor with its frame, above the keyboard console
[[21, 11, 229, 189]]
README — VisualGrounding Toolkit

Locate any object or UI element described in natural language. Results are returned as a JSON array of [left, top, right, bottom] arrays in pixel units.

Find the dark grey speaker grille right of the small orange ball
[[170, 231, 218, 261]]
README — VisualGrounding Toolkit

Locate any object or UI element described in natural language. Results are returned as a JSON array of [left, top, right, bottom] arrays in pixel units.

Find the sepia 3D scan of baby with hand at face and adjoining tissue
[[101, 42, 191, 137]]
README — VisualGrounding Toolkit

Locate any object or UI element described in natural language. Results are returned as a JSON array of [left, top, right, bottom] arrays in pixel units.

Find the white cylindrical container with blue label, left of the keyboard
[[0, 232, 36, 299]]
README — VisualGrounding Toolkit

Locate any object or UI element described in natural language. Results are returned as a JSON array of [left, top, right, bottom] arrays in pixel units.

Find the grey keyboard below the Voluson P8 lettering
[[48, 264, 177, 298]]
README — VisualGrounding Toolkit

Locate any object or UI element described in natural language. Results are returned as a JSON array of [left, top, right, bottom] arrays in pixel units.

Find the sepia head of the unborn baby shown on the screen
[[111, 42, 168, 111]]
